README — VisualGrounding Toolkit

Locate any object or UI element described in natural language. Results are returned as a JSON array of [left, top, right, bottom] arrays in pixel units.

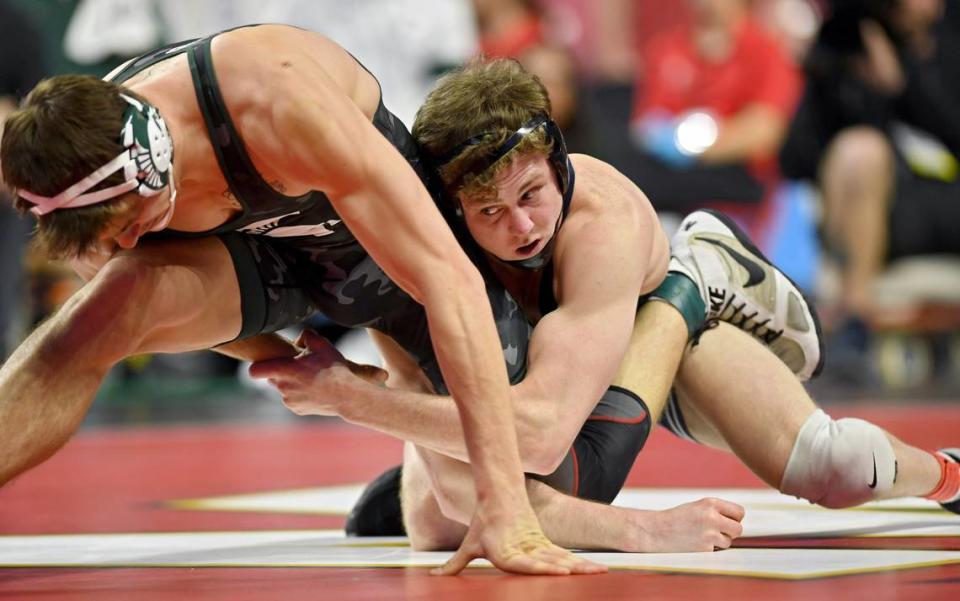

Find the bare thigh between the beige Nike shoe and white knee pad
[[677, 323, 816, 485]]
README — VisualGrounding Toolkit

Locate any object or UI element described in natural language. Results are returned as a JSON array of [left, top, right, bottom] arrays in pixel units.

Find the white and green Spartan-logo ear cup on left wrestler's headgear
[[120, 94, 173, 196]]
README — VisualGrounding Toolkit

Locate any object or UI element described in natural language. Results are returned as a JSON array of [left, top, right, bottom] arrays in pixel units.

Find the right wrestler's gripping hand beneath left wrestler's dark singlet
[[250, 330, 387, 415]]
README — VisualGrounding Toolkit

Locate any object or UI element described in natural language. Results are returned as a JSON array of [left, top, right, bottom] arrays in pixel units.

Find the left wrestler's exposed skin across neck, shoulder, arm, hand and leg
[[0, 26, 602, 574]]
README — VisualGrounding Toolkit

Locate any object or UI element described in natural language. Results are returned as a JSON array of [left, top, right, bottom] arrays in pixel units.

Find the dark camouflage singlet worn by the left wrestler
[[113, 27, 530, 392]]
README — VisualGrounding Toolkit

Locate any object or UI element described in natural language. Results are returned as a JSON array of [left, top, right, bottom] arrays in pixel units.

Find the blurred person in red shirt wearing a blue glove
[[610, 0, 800, 220]]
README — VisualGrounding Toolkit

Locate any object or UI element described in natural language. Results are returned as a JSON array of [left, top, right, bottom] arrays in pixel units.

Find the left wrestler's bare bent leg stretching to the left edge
[[0, 238, 262, 483]]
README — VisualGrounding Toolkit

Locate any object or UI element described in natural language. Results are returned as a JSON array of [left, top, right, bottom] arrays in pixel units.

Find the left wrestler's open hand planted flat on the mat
[[431, 504, 607, 576]]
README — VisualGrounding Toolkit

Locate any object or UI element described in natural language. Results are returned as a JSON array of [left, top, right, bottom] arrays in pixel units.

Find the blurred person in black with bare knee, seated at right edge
[[781, 0, 960, 322]]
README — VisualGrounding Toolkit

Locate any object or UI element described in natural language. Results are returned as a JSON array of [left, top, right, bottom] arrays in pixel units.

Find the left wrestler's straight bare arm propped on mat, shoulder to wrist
[[266, 69, 524, 502]]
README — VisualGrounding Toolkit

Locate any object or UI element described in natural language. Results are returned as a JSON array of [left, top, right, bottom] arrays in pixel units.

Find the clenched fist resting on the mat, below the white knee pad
[[630, 498, 746, 553]]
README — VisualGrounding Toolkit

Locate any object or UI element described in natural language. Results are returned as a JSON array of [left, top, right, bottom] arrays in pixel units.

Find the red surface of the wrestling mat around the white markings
[[0, 404, 960, 601]]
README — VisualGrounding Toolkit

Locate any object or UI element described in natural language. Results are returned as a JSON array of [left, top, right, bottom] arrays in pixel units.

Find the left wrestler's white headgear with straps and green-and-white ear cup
[[17, 94, 173, 217]]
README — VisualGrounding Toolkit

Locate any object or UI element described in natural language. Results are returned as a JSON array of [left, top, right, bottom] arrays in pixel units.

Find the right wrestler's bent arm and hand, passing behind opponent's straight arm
[[255, 159, 666, 473]]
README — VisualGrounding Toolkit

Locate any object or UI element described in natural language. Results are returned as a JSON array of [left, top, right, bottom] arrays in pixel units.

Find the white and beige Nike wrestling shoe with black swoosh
[[670, 210, 823, 380]]
